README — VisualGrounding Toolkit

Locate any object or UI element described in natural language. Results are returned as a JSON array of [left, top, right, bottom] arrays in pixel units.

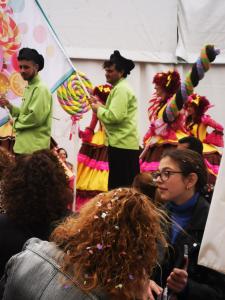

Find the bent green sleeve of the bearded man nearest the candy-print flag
[[15, 87, 52, 129]]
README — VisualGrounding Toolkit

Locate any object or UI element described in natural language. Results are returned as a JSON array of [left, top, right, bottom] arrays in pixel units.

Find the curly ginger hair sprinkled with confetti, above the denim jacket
[[51, 188, 166, 299]]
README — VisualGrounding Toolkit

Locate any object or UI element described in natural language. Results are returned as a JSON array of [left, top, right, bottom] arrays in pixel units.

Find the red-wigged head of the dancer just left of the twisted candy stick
[[153, 70, 180, 100]]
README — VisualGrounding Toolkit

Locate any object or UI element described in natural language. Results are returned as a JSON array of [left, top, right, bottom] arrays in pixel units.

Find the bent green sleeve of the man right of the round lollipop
[[97, 89, 128, 124]]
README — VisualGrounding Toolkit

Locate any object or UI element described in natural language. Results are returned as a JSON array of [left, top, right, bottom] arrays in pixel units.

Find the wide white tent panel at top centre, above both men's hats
[[40, 0, 177, 63]]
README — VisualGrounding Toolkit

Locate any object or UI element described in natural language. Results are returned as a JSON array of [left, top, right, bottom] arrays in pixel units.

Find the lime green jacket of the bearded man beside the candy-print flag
[[10, 75, 52, 154]]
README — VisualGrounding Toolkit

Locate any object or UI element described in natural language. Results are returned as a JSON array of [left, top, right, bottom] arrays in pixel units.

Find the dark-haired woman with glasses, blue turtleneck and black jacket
[[150, 149, 225, 300]]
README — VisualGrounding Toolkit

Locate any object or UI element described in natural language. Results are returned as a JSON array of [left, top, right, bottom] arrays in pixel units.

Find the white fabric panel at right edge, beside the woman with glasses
[[198, 154, 225, 274]]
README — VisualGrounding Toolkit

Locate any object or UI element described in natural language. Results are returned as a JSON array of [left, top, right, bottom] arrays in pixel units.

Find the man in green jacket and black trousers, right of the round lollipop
[[90, 50, 139, 189]]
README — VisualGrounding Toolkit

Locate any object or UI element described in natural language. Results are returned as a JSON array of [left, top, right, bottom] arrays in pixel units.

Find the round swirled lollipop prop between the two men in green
[[57, 72, 93, 121]]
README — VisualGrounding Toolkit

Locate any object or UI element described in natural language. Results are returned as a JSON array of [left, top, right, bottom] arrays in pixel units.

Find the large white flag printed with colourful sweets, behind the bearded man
[[0, 0, 75, 126]]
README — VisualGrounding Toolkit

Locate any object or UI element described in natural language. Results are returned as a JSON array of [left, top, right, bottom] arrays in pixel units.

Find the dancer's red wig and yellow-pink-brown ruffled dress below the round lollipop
[[76, 84, 111, 210]]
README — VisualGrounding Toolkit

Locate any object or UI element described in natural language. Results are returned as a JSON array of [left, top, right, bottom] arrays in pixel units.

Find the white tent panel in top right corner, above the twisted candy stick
[[176, 0, 225, 64]]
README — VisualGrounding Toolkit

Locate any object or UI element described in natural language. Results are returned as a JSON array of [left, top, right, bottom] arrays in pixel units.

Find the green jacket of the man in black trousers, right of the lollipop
[[97, 78, 139, 150]]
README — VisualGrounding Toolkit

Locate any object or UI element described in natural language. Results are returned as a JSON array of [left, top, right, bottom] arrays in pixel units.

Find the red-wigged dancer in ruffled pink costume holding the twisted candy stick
[[140, 71, 187, 172]]
